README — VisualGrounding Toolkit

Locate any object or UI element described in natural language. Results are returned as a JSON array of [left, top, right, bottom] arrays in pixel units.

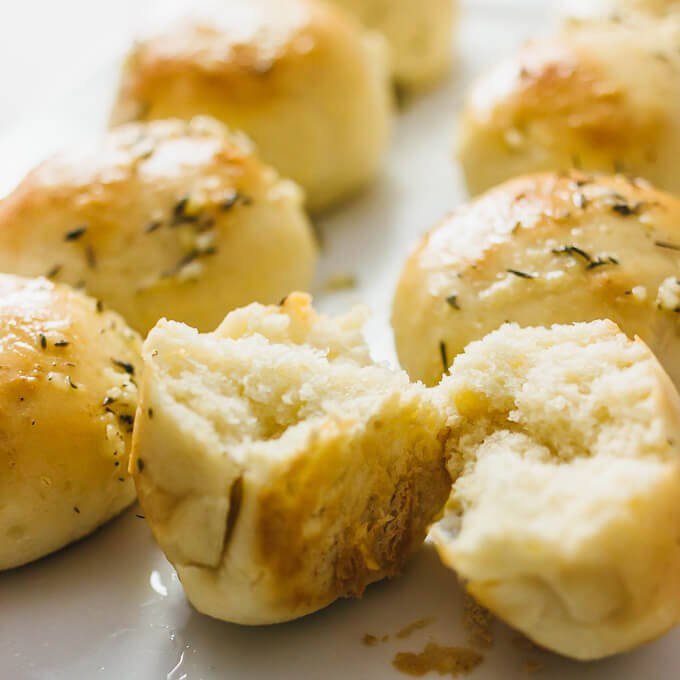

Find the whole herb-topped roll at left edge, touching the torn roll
[[0, 274, 141, 569]]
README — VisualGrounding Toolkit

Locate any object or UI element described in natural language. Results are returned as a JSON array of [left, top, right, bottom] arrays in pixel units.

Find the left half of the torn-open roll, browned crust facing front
[[130, 294, 451, 624]]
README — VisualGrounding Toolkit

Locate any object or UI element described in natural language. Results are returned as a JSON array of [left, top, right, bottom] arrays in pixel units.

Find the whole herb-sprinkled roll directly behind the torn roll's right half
[[392, 171, 680, 385]]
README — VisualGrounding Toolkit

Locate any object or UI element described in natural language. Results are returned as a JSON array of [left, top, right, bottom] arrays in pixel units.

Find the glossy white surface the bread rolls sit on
[[0, 1, 680, 680]]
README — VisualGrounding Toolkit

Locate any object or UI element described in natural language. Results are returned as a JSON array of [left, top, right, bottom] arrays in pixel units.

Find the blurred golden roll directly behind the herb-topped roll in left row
[[112, 0, 392, 211]]
